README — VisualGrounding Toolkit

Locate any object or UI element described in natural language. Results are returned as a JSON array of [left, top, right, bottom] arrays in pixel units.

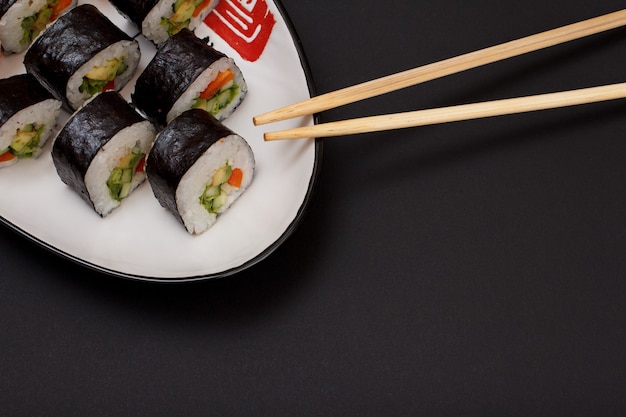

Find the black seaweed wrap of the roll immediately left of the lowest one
[[52, 91, 145, 211]]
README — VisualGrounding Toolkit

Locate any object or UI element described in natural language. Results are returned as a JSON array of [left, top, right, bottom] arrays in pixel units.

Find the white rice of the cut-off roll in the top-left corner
[[0, 0, 47, 53]]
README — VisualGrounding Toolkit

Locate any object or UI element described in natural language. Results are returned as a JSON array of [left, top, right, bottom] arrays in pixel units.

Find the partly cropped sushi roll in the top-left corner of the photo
[[0, 0, 76, 54]]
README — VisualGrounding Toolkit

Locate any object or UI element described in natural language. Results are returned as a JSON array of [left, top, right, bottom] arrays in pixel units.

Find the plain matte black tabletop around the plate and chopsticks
[[0, 0, 626, 417]]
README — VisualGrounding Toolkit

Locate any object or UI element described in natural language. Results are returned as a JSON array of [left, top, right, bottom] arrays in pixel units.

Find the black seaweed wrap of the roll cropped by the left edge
[[0, 74, 54, 126]]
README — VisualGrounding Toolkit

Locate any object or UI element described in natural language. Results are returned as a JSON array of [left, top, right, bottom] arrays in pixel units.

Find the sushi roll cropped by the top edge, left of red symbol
[[110, 0, 219, 45]]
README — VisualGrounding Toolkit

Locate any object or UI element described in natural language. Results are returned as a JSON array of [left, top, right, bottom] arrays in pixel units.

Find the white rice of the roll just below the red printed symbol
[[167, 57, 248, 123]]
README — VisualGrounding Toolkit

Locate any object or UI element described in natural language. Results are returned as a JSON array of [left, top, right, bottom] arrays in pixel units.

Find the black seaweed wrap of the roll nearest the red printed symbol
[[132, 29, 226, 126]]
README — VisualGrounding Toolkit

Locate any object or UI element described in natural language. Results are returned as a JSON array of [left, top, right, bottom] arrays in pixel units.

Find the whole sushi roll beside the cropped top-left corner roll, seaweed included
[[24, 4, 141, 111]]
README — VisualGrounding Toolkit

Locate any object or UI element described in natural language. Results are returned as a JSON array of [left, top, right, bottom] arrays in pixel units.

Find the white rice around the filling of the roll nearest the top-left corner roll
[[65, 40, 141, 110]]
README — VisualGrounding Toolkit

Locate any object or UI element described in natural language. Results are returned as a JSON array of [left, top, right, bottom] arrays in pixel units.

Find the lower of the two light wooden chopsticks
[[264, 83, 626, 141]]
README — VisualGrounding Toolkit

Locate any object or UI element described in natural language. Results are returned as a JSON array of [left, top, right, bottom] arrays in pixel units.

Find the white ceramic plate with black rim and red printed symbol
[[0, 0, 321, 282]]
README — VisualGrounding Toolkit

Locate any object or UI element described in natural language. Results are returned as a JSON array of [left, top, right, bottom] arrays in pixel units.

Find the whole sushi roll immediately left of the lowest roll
[[52, 91, 156, 217]]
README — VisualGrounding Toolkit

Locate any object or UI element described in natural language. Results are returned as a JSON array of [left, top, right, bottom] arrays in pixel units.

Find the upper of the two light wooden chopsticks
[[252, 9, 626, 125]]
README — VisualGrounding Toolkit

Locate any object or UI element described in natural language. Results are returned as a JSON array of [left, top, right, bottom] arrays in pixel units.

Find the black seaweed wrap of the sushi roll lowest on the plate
[[146, 109, 236, 222]]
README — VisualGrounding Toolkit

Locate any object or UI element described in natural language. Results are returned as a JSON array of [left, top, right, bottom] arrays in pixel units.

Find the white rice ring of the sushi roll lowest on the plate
[[176, 135, 255, 235]]
